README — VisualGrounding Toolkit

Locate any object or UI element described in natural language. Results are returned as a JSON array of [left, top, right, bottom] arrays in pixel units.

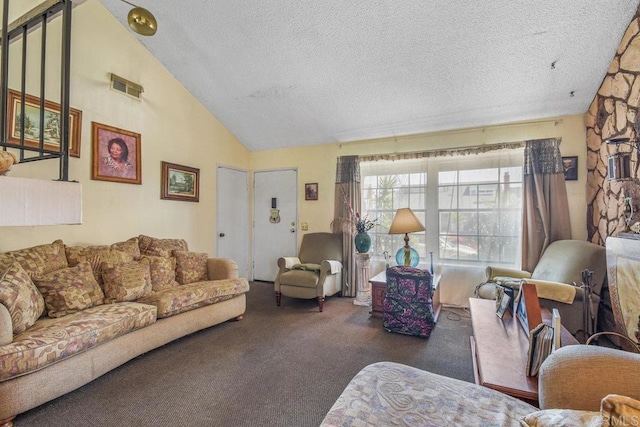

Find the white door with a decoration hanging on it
[[253, 169, 298, 282]]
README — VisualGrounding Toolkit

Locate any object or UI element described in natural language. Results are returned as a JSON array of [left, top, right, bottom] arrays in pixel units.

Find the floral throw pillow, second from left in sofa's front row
[[34, 261, 104, 317]]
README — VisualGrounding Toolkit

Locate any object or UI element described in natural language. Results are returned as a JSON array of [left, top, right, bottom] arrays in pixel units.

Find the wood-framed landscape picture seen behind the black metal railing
[[7, 89, 82, 157]]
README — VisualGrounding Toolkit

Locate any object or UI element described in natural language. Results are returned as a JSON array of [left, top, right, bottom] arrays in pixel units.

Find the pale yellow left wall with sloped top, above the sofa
[[0, 0, 249, 254]]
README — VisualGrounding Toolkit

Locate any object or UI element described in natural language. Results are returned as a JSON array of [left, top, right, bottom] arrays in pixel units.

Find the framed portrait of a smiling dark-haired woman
[[91, 122, 142, 184]]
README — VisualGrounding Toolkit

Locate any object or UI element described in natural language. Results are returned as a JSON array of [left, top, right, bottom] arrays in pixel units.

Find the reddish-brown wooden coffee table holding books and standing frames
[[469, 298, 579, 406]]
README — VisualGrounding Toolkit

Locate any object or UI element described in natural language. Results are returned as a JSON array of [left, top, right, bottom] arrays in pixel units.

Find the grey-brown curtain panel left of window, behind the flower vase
[[331, 156, 360, 297]]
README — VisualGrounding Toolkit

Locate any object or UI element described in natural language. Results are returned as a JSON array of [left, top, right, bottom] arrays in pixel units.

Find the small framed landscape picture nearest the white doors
[[160, 162, 200, 202]]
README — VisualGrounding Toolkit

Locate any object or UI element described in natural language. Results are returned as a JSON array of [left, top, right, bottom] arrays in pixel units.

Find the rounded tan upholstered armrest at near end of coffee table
[[538, 345, 640, 411]]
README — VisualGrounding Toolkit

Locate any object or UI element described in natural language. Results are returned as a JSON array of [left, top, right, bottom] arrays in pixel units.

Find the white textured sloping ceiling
[[102, 0, 638, 151]]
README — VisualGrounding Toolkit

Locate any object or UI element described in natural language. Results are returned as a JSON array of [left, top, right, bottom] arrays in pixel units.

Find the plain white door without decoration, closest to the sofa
[[216, 166, 251, 279]]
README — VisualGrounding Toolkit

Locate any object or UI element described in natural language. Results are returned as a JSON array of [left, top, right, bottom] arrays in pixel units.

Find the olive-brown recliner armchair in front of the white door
[[274, 233, 343, 311]]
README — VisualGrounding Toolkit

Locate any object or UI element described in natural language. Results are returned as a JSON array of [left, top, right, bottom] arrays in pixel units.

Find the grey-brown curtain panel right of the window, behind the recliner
[[522, 138, 571, 271]]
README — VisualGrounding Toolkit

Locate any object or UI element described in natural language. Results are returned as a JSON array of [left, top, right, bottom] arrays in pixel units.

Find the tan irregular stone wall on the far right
[[585, 8, 640, 245]]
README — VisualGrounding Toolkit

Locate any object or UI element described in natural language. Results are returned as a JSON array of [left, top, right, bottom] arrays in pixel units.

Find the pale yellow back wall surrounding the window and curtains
[[251, 115, 587, 246]]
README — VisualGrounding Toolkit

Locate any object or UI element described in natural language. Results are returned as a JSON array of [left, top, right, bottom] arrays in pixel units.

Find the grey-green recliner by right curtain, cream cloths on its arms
[[474, 240, 607, 336]]
